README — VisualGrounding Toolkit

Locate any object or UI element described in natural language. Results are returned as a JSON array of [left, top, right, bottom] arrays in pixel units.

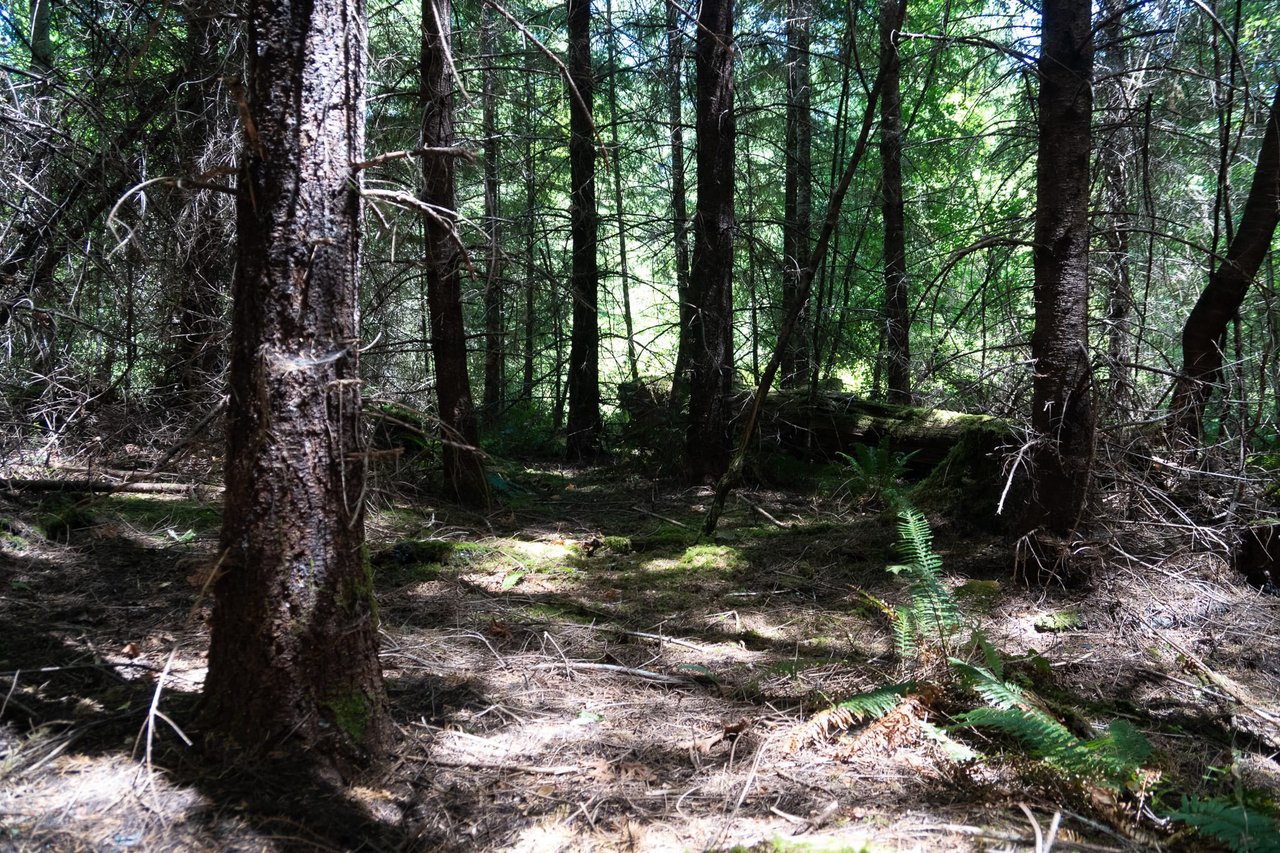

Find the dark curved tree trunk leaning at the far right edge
[[1169, 86, 1280, 446]]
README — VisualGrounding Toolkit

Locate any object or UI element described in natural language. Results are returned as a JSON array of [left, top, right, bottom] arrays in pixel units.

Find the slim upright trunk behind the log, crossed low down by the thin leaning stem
[[780, 0, 813, 388]]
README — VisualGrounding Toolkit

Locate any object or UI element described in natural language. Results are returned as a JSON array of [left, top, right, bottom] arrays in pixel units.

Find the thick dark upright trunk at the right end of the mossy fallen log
[[1023, 0, 1093, 535]]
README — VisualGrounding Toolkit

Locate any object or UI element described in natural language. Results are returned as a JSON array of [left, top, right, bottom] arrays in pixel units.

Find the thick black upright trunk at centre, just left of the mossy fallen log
[[686, 0, 736, 480]]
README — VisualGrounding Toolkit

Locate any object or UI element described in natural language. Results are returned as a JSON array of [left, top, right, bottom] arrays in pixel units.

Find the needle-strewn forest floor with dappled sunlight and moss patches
[[0, 448, 1280, 852]]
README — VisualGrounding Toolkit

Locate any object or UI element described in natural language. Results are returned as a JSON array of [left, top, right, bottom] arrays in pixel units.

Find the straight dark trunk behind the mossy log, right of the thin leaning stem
[[879, 0, 911, 405]]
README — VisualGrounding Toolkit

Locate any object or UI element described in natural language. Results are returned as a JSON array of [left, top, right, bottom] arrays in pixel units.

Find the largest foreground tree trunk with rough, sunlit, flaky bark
[[202, 0, 392, 768]]
